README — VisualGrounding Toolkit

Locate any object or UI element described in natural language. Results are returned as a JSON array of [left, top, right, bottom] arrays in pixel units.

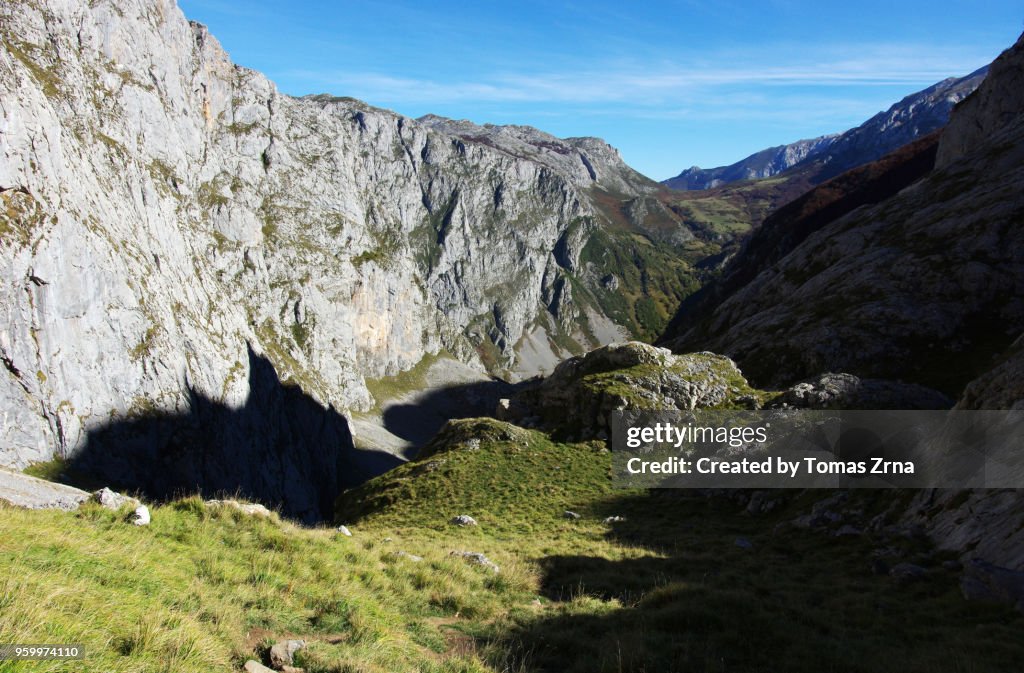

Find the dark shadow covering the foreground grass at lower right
[[487, 492, 1024, 673]]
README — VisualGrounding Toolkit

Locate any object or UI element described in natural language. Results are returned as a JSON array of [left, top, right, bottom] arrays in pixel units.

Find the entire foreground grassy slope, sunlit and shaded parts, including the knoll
[[0, 420, 1024, 673]]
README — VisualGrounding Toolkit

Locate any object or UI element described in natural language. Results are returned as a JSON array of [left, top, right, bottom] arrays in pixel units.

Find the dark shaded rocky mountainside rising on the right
[[668, 32, 1024, 397]]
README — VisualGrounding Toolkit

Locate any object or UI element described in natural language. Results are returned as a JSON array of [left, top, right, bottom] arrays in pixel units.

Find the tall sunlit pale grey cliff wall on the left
[[0, 0, 652, 467]]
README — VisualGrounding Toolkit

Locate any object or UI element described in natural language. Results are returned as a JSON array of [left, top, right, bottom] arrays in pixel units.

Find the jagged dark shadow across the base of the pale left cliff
[[69, 347, 401, 523]]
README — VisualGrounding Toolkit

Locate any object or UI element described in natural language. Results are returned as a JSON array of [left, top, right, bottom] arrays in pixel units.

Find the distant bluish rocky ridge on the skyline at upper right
[[664, 66, 988, 190]]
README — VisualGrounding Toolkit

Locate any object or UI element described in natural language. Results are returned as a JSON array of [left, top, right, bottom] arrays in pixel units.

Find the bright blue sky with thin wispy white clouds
[[180, 0, 1024, 179]]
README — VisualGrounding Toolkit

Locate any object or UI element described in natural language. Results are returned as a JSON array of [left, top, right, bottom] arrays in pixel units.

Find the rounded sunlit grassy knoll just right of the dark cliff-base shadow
[[337, 418, 611, 539]]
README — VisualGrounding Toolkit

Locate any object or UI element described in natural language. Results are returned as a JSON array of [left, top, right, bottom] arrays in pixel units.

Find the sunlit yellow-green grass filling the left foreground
[[0, 498, 507, 673]]
